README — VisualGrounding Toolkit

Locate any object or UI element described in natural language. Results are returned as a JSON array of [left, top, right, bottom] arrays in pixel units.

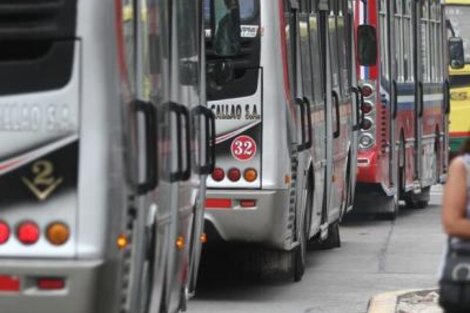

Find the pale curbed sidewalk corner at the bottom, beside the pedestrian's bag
[[368, 289, 442, 313]]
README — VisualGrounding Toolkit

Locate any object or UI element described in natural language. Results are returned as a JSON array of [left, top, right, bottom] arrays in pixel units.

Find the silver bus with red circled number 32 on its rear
[[205, 0, 361, 280]]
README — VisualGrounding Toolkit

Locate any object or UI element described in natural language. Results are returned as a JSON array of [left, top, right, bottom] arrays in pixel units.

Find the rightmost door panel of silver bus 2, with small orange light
[[167, 1, 206, 312]]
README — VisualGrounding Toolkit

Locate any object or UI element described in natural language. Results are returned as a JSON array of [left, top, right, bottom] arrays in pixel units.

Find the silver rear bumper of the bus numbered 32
[[205, 190, 293, 250]]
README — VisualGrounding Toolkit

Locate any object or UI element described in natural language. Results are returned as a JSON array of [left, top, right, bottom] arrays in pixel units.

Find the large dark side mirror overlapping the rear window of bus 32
[[211, 0, 241, 57]]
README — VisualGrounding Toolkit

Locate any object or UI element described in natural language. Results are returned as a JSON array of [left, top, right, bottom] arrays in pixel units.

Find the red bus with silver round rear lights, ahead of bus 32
[[354, 0, 449, 219]]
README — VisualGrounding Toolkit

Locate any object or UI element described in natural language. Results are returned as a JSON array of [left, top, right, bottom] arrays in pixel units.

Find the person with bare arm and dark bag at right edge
[[440, 139, 470, 313]]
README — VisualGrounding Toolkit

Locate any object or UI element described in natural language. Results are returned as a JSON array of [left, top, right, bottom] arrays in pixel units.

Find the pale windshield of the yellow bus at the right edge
[[446, 6, 470, 64]]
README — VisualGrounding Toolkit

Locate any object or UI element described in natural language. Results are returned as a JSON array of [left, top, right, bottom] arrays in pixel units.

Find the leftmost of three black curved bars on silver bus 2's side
[[134, 100, 158, 195]]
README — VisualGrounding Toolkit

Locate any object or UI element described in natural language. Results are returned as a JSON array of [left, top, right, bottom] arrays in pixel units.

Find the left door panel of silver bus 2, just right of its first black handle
[[131, 0, 176, 312]]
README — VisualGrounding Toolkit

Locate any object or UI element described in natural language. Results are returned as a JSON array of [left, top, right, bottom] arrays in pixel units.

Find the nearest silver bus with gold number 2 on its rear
[[0, 0, 215, 313]]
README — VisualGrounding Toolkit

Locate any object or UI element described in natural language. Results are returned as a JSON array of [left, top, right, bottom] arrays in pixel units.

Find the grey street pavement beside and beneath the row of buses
[[188, 187, 445, 313]]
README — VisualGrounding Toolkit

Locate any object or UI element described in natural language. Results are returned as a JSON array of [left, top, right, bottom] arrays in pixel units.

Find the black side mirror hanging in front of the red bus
[[357, 25, 377, 66]]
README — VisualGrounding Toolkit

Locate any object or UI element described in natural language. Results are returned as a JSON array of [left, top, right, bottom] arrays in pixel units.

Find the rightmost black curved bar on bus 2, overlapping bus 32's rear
[[193, 105, 216, 175]]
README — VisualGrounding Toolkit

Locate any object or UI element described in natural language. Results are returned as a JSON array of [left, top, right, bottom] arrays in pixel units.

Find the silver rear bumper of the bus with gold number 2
[[0, 259, 114, 313]]
